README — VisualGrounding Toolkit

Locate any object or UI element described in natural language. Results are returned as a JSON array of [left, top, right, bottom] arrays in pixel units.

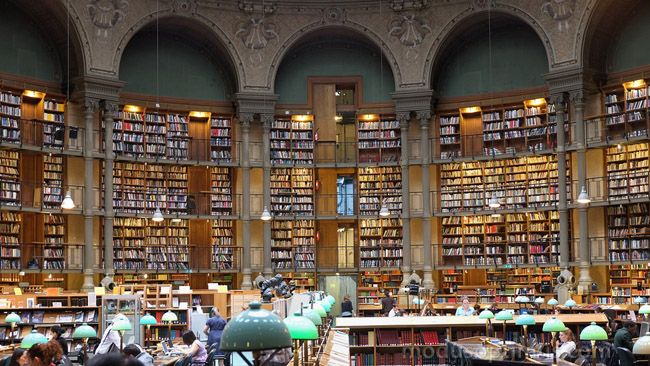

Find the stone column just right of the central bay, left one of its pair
[[397, 113, 411, 287]]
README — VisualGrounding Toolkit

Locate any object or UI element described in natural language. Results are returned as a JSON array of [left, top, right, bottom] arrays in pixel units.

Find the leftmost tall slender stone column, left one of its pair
[[81, 99, 98, 292]]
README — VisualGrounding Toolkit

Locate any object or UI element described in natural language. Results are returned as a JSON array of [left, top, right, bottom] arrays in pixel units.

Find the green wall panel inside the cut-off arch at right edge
[[607, 4, 650, 72]]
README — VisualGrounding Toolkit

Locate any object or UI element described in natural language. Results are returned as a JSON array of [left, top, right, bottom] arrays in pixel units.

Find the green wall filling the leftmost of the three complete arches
[[119, 35, 232, 101]]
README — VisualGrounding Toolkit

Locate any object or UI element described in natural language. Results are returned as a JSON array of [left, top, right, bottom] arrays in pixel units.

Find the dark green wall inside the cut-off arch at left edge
[[0, 1, 61, 81]]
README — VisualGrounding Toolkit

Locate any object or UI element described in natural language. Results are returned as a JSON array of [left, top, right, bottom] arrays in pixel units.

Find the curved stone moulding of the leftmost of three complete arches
[[112, 9, 246, 91]]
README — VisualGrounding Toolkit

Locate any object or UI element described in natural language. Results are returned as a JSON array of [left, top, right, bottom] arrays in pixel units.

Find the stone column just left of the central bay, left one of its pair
[[239, 113, 253, 290]]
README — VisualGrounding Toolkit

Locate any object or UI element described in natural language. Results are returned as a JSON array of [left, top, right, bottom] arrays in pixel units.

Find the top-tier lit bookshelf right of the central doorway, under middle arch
[[357, 114, 402, 163]]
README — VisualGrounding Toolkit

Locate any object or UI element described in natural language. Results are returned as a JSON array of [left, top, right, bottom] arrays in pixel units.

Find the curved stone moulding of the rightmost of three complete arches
[[422, 4, 555, 89]]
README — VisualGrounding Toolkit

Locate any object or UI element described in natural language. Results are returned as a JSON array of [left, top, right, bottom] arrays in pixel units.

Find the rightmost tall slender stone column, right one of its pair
[[570, 90, 592, 293]]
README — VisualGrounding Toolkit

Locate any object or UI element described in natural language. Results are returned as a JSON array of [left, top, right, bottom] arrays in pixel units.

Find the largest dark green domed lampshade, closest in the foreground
[[219, 301, 291, 351]]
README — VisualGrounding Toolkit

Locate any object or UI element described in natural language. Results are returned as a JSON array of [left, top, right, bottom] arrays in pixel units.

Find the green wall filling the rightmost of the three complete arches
[[434, 27, 549, 97]]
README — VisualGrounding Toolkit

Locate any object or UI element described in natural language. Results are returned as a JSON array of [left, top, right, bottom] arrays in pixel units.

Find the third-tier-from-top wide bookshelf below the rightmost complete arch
[[442, 211, 559, 266]]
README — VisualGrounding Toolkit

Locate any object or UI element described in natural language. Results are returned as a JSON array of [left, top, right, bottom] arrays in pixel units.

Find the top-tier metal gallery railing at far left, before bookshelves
[[0, 117, 85, 153]]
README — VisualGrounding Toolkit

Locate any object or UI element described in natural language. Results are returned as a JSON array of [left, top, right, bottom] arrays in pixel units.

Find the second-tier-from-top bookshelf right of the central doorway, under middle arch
[[358, 167, 402, 216]]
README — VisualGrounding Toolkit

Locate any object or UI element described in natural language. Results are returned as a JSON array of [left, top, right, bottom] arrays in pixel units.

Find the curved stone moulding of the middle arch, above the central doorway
[[267, 22, 401, 94]]
